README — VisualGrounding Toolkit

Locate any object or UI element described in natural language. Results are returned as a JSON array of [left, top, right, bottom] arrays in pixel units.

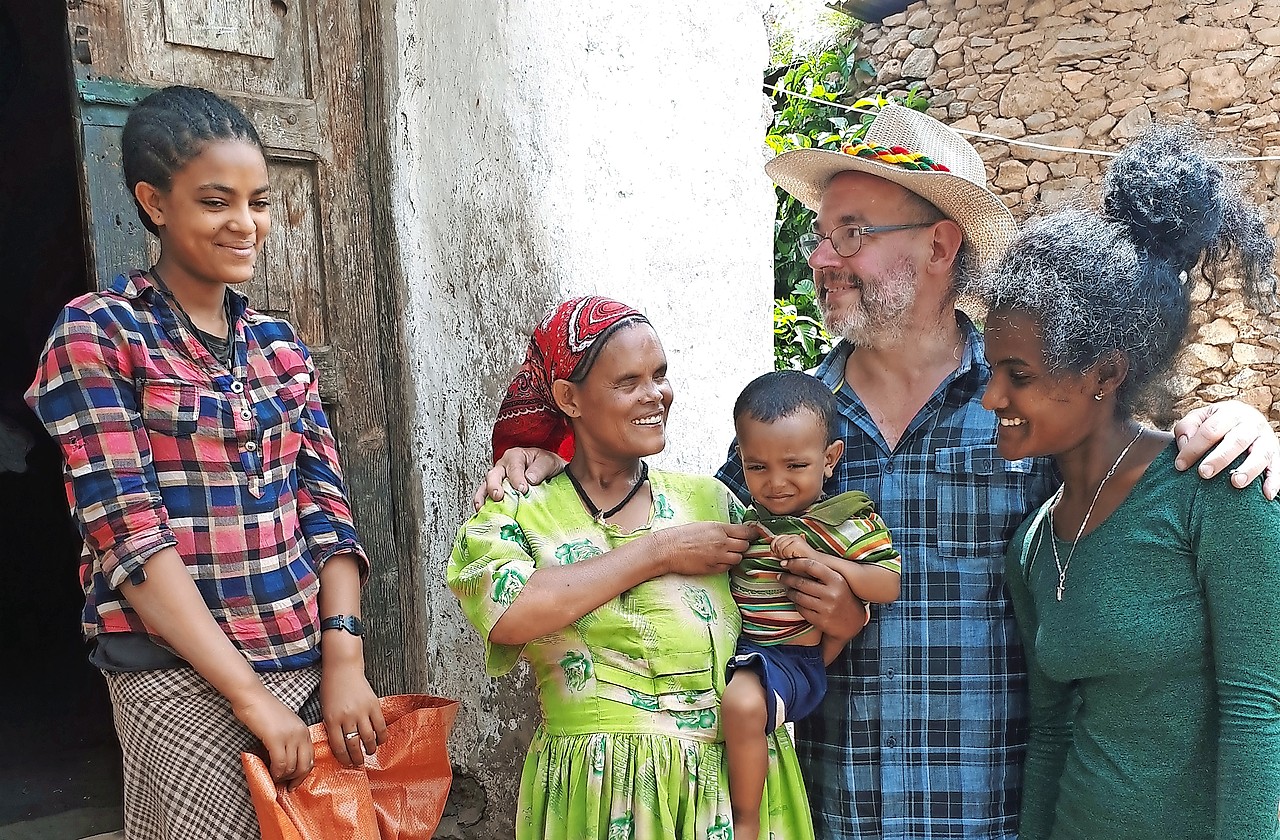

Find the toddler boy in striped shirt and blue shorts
[[721, 370, 901, 840]]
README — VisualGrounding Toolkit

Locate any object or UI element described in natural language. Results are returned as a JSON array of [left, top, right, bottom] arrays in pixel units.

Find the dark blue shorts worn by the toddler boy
[[727, 639, 827, 732]]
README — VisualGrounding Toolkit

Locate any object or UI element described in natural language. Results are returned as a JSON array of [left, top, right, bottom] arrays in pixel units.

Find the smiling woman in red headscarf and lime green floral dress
[[448, 297, 813, 840]]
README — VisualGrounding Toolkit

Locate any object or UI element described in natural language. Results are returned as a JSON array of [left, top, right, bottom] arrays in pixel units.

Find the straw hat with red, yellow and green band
[[764, 105, 1018, 265]]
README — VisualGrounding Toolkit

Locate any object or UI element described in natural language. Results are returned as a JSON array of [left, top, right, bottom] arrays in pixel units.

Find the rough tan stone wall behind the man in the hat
[[860, 0, 1280, 423]]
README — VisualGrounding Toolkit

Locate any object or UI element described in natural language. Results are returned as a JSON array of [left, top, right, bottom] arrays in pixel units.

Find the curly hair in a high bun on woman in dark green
[[978, 127, 1276, 414]]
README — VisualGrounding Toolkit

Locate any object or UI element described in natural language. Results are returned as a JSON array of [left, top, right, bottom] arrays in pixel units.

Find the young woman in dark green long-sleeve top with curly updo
[[983, 128, 1280, 840]]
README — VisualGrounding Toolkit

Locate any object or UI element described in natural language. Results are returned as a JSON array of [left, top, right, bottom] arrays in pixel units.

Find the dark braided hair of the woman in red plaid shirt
[[122, 85, 262, 234]]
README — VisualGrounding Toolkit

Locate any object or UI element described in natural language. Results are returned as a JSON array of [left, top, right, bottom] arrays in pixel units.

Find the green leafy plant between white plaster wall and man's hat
[[764, 38, 928, 370]]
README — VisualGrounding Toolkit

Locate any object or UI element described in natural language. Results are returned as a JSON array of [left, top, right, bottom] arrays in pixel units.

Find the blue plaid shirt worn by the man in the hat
[[719, 312, 1059, 840]]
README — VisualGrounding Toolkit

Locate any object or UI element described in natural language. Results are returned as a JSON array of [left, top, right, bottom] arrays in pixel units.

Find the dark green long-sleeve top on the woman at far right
[[1007, 447, 1280, 840]]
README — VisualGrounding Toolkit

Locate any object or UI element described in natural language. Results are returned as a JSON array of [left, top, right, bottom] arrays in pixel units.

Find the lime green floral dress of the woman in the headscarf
[[448, 471, 814, 840]]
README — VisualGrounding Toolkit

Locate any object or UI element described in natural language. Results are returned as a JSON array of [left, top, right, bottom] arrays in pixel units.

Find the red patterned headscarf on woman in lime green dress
[[493, 297, 649, 461]]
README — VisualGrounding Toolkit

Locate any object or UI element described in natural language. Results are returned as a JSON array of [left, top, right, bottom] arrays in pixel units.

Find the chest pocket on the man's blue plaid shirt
[[934, 444, 1032, 563]]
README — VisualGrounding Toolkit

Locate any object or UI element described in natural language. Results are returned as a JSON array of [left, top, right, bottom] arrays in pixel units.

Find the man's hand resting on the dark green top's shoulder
[[1174, 400, 1280, 499]]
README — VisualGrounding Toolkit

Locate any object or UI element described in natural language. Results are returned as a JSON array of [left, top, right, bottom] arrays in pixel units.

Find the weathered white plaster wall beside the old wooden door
[[384, 0, 773, 837]]
